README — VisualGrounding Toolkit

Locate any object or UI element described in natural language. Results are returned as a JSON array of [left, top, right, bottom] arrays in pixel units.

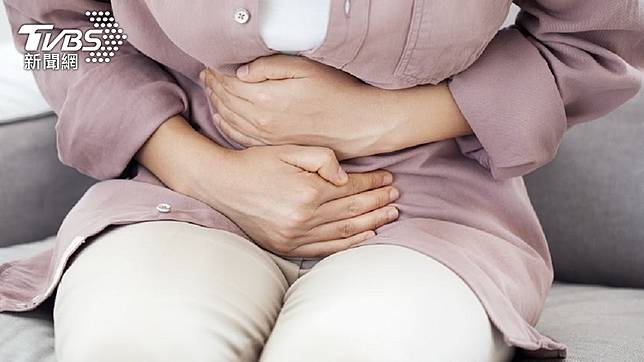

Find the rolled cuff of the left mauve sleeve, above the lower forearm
[[56, 55, 188, 180]]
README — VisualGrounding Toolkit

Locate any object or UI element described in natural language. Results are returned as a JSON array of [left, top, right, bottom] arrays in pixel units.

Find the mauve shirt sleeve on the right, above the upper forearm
[[448, 0, 644, 179]]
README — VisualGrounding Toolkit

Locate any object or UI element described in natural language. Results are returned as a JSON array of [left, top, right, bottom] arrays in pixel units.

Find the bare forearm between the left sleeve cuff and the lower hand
[[136, 116, 232, 206]]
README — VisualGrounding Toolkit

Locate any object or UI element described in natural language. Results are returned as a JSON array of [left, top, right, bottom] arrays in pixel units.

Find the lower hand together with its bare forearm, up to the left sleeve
[[137, 116, 398, 257]]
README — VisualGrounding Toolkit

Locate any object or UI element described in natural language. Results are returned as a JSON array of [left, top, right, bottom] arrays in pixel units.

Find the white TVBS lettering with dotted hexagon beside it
[[18, 11, 127, 68]]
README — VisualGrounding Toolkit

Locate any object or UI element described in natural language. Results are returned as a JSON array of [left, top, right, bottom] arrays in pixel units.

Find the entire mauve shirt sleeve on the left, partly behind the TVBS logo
[[4, 0, 188, 179]]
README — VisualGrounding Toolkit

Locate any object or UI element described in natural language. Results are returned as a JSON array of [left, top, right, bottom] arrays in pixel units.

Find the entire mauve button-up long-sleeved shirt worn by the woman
[[0, 0, 644, 357]]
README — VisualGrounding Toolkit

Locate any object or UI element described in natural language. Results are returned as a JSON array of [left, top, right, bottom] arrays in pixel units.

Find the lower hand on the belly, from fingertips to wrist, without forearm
[[195, 145, 399, 257]]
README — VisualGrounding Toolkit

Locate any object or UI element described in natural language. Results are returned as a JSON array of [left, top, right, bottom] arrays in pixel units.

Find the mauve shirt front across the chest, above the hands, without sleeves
[[117, 0, 511, 89]]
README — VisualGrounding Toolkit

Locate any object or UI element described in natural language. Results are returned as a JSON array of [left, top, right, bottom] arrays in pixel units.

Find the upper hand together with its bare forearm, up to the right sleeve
[[202, 55, 472, 160]]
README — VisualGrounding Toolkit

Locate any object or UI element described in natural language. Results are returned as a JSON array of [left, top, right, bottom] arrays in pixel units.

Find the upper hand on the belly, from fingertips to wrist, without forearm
[[202, 55, 396, 160]]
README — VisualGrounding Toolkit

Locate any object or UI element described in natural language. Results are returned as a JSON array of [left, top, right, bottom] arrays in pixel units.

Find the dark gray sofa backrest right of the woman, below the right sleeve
[[526, 93, 644, 287]]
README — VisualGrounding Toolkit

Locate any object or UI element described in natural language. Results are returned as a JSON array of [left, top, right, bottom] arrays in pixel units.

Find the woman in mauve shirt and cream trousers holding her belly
[[0, 0, 644, 362]]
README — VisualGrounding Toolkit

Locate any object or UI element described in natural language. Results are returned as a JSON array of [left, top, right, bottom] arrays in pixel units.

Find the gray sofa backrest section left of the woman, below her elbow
[[0, 115, 93, 247]]
